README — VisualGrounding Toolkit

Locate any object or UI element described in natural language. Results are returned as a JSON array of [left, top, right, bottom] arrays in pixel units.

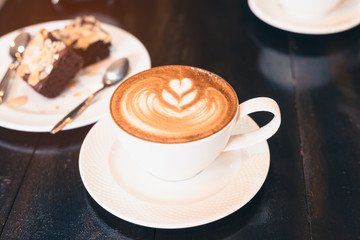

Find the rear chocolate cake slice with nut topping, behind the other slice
[[51, 16, 111, 66]]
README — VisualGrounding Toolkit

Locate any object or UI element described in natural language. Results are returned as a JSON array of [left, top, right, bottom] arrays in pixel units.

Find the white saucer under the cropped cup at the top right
[[248, 0, 360, 34]]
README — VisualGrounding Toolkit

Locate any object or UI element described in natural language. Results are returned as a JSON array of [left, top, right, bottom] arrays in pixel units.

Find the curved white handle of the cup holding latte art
[[224, 97, 281, 151]]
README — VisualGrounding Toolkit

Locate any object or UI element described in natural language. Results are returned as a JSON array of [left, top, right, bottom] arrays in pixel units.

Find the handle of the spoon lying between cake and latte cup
[[50, 86, 106, 134]]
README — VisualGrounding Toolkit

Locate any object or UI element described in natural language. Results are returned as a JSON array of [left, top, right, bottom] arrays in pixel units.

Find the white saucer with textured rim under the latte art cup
[[79, 116, 270, 228]]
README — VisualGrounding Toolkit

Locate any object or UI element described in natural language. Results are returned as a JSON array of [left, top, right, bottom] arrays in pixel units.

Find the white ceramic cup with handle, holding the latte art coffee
[[110, 66, 281, 181]]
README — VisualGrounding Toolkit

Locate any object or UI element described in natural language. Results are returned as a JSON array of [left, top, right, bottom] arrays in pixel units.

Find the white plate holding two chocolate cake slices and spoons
[[0, 20, 151, 132]]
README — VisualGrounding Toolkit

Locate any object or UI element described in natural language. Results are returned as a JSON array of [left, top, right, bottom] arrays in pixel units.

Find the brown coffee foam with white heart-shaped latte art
[[110, 66, 238, 143]]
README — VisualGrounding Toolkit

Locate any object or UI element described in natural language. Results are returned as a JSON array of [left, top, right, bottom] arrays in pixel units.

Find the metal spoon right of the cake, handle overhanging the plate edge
[[50, 58, 129, 134]]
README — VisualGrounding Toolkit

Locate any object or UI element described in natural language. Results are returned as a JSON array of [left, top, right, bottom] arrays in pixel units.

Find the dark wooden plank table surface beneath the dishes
[[0, 0, 360, 240]]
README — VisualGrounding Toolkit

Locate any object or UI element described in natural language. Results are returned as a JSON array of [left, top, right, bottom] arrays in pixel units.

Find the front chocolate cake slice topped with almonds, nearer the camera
[[17, 29, 83, 98]]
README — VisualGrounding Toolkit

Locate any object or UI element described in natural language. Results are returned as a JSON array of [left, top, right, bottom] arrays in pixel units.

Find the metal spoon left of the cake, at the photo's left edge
[[0, 32, 30, 104]]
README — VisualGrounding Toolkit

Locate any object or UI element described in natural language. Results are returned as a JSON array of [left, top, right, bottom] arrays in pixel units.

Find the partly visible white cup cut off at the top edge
[[278, 0, 342, 20]]
